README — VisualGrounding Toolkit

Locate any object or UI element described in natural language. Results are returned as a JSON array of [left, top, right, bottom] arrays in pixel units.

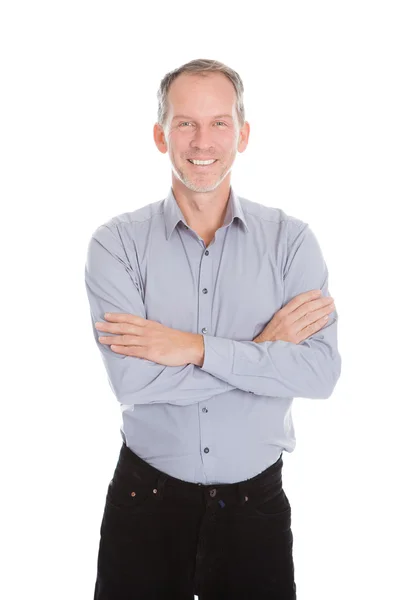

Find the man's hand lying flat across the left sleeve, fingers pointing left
[[95, 313, 204, 367]]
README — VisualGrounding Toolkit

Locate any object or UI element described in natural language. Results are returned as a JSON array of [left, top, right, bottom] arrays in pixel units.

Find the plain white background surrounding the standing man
[[0, 0, 400, 600]]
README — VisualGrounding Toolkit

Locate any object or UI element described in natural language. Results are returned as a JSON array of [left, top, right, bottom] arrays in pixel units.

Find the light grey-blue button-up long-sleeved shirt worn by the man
[[85, 186, 341, 484]]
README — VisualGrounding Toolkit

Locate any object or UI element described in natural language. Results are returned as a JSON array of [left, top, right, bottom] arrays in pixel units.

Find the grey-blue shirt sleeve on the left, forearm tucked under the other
[[85, 225, 234, 405]]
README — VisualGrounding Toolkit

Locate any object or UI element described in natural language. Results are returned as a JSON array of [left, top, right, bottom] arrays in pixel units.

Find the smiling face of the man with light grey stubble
[[159, 73, 248, 192]]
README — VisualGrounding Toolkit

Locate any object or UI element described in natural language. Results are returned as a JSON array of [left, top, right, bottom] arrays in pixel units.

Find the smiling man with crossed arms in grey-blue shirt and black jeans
[[85, 59, 341, 600]]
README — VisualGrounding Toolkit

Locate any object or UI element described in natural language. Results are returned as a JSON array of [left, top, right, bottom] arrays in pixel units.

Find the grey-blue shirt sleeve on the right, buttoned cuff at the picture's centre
[[200, 218, 341, 398]]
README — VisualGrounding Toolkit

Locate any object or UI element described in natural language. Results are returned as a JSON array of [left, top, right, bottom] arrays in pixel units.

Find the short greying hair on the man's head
[[157, 58, 245, 128]]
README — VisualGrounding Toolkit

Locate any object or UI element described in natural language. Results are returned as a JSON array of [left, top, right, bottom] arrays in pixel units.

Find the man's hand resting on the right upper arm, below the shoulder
[[253, 290, 335, 344]]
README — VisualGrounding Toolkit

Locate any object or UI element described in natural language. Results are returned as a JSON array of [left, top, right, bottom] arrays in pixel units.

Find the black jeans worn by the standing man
[[94, 442, 296, 600]]
